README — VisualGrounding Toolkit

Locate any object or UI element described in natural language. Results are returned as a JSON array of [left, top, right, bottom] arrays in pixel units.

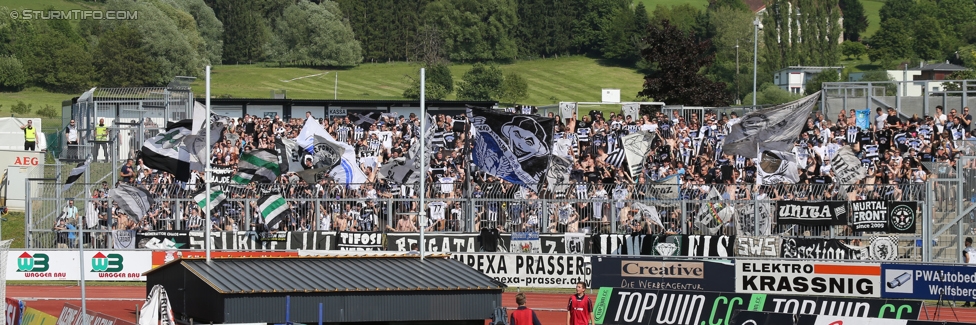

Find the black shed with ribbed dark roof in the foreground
[[146, 255, 505, 324]]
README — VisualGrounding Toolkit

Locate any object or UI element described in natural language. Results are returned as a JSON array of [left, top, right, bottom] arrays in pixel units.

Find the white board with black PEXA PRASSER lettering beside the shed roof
[[451, 253, 592, 288]]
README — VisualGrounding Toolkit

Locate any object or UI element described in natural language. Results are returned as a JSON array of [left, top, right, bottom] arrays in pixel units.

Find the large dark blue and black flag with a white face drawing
[[468, 107, 556, 190]]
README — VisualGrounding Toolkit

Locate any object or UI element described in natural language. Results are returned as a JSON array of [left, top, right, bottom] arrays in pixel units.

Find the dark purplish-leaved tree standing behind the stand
[[638, 20, 729, 106]]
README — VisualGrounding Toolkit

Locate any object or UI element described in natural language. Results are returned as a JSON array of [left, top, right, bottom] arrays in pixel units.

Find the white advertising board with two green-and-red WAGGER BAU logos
[[7, 250, 152, 281]]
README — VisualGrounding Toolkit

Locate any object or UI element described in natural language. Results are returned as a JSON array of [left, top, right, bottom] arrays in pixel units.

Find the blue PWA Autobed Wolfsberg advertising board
[[881, 264, 976, 301]]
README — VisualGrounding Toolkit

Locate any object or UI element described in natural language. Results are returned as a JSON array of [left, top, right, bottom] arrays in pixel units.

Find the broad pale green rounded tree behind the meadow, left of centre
[[271, 0, 363, 66]]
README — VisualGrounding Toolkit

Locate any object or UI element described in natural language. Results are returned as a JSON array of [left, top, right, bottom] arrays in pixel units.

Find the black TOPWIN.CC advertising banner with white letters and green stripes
[[593, 287, 922, 325]]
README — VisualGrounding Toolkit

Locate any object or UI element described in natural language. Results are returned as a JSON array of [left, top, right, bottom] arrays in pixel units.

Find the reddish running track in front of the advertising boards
[[7, 286, 976, 325]]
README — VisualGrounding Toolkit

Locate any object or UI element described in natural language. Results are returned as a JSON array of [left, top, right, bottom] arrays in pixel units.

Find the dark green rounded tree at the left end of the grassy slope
[[95, 23, 159, 87]]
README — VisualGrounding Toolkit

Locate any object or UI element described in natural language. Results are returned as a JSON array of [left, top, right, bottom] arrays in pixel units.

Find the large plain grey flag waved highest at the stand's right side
[[722, 91, 820, 158]]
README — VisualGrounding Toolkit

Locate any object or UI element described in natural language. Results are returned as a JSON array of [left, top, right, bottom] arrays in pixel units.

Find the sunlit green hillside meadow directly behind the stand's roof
[[193, 56, 643, 105]]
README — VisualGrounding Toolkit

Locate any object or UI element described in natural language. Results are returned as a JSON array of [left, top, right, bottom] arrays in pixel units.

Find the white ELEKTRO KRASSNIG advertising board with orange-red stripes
[[735, 260, 883, 298]]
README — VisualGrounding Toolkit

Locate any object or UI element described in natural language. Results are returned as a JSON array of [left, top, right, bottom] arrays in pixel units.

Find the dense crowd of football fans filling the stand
[[55, 107, 976, 247]]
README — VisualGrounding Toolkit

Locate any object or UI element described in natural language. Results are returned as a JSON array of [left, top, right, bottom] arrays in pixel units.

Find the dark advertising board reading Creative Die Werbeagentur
[[592, 256, 735, 292]]
